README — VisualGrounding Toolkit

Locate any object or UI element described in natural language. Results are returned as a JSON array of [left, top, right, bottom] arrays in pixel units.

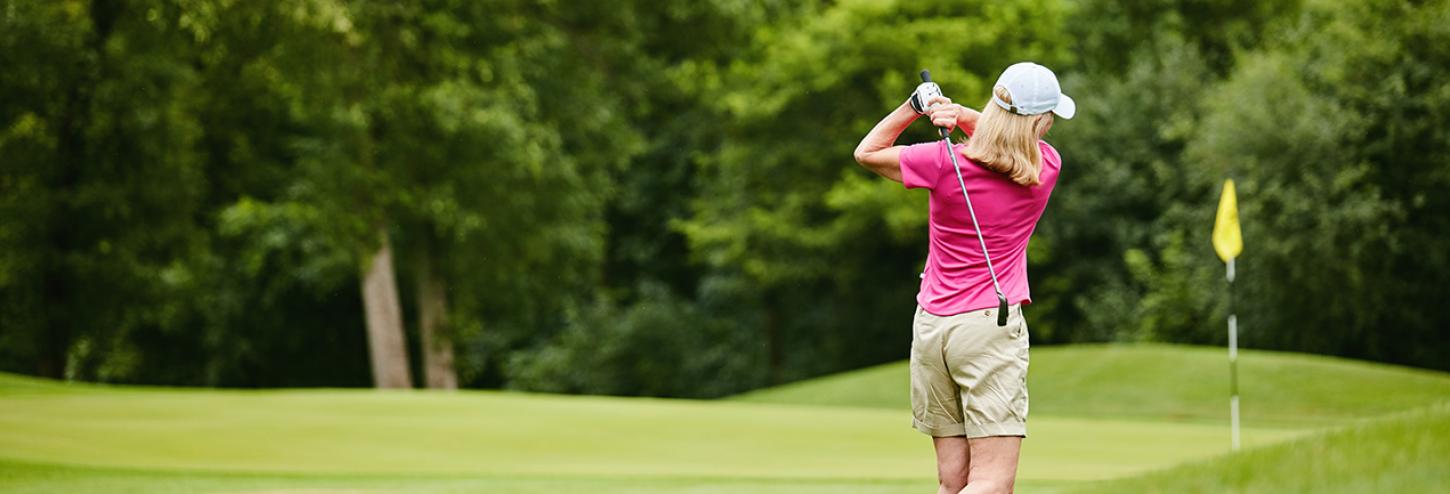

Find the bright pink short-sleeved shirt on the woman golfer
[[900, 141, 1063, 316]]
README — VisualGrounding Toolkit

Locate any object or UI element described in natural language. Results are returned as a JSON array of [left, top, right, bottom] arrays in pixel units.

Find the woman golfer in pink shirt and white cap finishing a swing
[[856, 62, 1076, 493]]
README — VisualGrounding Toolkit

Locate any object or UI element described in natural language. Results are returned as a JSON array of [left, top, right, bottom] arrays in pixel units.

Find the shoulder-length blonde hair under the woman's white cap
[[963, 85, 1053, 185]]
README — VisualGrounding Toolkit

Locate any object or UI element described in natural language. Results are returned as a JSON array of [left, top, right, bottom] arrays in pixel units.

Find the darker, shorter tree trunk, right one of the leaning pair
[[418, 255, 458, 390]]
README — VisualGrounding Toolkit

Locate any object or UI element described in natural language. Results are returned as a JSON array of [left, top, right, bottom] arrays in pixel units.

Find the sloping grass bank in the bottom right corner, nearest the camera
[[1079, 406, 1450, 494]]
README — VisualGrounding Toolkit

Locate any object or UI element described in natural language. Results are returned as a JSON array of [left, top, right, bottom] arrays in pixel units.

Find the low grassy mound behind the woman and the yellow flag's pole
[[734, 345, 1450, 426]]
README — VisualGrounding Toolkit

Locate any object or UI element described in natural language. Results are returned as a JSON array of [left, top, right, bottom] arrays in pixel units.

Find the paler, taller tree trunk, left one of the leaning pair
[[363, 227, 413, 388]]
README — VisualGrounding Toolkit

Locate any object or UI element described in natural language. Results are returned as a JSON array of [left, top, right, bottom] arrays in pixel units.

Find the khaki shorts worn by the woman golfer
[[911, 306, 1028, 438]]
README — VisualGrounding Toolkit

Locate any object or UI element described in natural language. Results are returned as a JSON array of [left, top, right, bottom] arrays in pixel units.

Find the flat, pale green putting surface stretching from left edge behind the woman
[[0, 379, 1295, 481]]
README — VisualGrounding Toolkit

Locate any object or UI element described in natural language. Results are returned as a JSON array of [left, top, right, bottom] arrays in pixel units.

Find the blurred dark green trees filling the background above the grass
[[0, 0, 1450, 397]]
